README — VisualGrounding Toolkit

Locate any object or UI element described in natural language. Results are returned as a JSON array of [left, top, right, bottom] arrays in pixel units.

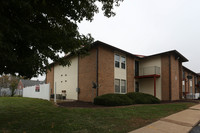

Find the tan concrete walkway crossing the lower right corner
[[130, 104, 200, 133]]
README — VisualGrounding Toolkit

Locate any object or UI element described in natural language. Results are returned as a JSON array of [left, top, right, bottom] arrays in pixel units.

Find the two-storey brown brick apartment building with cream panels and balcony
[[46, 41, 200, 101]]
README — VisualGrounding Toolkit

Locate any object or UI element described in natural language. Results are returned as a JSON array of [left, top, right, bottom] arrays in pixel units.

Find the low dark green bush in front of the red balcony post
[[126, 92, 160, 104]]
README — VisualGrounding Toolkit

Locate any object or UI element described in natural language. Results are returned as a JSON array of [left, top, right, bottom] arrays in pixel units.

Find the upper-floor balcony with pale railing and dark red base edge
[[135, 66, 160, 78]]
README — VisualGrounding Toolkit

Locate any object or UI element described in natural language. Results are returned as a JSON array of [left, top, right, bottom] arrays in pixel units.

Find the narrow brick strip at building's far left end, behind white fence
[[46, 66, 54, 94]]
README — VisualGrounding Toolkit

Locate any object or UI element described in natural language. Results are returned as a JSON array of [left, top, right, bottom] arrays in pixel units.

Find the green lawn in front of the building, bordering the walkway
[[0, 97, 195, 133]]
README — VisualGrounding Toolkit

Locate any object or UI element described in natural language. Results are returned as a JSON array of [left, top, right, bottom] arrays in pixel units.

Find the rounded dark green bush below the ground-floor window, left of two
[[94, 94, 132, 106]]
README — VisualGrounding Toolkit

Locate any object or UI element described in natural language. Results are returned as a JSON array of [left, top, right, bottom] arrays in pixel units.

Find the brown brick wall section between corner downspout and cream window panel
[[98, 46, 114, 96]]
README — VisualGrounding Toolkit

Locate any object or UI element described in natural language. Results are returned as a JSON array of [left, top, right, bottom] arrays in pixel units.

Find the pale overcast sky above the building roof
[[33, 0, 200, 80]]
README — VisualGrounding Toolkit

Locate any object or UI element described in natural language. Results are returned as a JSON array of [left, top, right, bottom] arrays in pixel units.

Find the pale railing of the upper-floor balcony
[[139, 66, 160, 76]]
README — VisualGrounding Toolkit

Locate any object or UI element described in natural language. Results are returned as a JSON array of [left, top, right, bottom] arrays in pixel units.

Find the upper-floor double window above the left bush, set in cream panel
[[115, 54, 126, 69]]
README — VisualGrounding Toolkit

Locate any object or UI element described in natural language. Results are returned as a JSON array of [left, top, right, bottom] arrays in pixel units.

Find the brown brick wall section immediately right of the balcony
[[161, 54, 182, 101]]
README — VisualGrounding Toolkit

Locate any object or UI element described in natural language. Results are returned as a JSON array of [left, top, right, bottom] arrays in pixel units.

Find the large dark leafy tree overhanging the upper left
[[0, 0, 123, 78]]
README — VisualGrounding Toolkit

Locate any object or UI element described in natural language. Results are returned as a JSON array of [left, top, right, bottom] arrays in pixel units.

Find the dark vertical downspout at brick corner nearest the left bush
[[96, 45, 99, 96]]
